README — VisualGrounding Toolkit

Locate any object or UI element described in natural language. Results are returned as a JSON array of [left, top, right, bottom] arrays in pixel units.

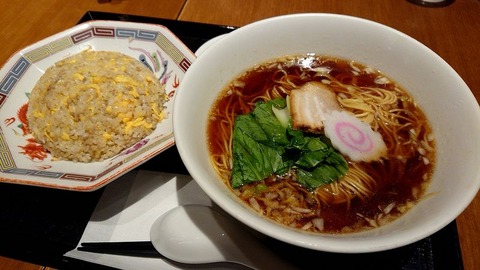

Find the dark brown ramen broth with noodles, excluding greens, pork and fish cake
[[207, 55, 435, 233]]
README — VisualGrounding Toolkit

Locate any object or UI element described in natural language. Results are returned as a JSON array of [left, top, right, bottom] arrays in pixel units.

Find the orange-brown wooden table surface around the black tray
[[0, 0, 480, 270]]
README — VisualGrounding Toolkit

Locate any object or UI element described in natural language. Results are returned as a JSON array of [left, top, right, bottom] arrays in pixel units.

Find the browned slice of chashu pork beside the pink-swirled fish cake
[[290, 82, 341, 134]]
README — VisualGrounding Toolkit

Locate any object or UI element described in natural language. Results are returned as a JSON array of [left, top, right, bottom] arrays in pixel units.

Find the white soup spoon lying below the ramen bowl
[[150, 205, 293, 269]]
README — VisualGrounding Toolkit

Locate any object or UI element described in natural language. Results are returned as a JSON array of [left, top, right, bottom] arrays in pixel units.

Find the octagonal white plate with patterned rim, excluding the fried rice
[[0, 21, 195, 191]]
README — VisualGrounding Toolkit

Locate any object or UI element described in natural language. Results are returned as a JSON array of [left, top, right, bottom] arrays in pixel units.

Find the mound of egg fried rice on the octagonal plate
[[27, 50, 167, 162]]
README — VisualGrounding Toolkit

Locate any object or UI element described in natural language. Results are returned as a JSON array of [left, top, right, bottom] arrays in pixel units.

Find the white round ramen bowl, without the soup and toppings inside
[[173, 14, 480, 253]]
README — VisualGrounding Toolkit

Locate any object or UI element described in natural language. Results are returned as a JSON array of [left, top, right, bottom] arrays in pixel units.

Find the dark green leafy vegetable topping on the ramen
[[231, 98, 348, 189]]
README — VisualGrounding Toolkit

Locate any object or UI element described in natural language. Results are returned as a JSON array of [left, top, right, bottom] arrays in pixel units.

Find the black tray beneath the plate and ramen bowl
[[0, 11, 463, 270]]
